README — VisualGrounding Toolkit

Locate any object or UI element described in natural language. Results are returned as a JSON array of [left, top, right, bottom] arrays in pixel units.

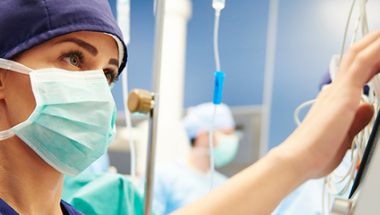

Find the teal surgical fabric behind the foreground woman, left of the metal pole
[[62, 173, 150, 215]]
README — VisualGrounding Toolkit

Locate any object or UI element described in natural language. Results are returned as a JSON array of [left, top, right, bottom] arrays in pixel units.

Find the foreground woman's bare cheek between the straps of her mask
[[5, 71, 36, 127]]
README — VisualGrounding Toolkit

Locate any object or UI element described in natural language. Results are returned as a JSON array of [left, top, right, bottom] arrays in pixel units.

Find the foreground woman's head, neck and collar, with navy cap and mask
[[0, 0, 127, 215]]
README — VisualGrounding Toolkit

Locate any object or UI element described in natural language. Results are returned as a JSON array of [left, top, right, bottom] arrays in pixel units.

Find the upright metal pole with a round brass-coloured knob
[[128, 0, 165, 215]]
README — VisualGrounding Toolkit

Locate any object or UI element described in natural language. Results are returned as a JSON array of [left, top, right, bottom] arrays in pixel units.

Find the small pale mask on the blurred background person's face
[[213, 134, 239, 167]]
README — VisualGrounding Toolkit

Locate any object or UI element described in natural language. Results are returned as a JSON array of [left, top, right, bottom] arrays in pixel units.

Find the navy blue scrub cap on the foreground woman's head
[[0, 0, 127, 74]]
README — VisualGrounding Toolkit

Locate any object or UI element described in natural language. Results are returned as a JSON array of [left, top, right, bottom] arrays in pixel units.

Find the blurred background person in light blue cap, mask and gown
[[153, 102, 239, 214]]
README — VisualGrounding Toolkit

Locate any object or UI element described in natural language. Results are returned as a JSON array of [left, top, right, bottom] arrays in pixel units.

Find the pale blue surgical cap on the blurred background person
[[182, 102, 235, 139]]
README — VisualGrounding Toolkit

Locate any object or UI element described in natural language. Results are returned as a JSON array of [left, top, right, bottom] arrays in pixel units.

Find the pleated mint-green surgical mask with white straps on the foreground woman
[[0, 59, 116, 176]]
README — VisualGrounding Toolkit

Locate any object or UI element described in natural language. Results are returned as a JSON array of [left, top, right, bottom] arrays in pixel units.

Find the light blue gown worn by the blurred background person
[[146, 161, 228, 214]]
